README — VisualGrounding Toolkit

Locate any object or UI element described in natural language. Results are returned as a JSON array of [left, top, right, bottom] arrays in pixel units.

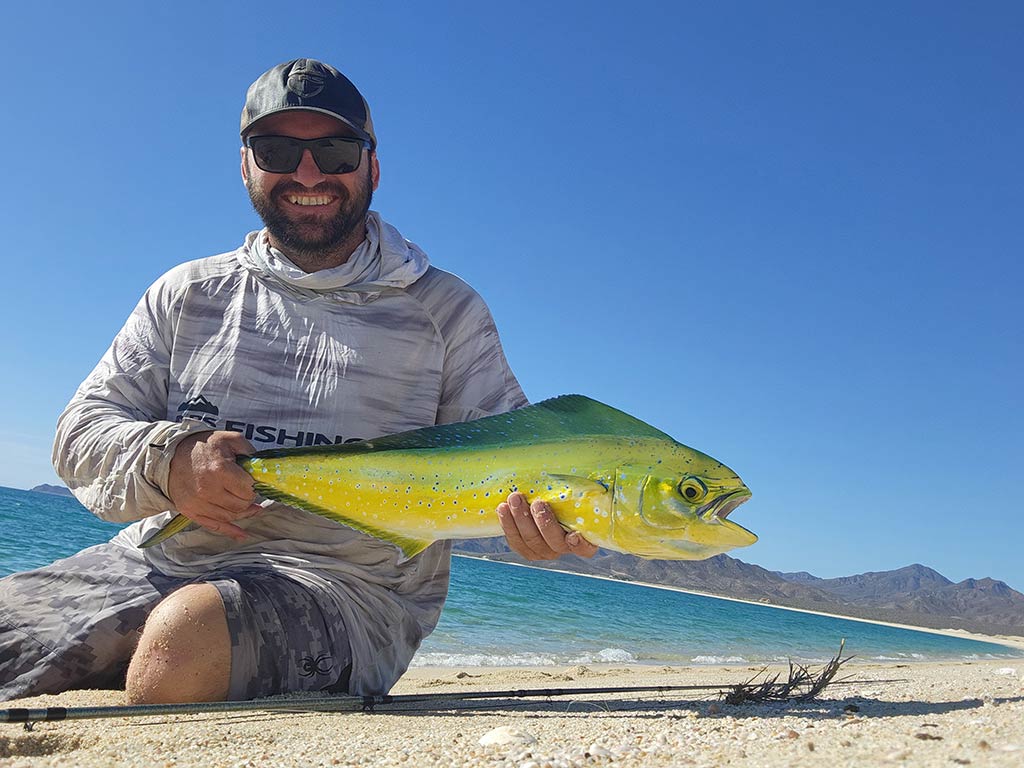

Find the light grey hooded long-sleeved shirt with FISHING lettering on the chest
[[53, 212, 526, 694]]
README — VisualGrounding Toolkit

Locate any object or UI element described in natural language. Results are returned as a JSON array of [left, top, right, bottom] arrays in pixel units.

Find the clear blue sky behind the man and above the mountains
[[0, 0, 1024, 590]]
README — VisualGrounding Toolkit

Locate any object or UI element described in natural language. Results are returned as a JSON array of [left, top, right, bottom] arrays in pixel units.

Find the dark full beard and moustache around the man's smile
[[246, 158, 374, 264]]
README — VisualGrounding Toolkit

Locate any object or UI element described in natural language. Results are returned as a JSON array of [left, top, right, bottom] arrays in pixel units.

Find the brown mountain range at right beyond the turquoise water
[[455, 539, 1024, 636]]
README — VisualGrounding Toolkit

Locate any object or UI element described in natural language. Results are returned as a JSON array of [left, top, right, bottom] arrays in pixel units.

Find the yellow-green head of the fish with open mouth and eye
[[611, 452, 758, 560]]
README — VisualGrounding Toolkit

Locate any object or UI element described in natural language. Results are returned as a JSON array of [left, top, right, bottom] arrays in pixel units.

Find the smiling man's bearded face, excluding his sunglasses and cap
[[242, 111, 380, 263]]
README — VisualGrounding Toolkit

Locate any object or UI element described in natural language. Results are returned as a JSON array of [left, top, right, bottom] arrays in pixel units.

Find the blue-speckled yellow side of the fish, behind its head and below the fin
[[247, 442, 622, 557]]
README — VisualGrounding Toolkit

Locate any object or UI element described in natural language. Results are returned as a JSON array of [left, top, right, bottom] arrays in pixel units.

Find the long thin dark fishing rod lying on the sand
[[0, 680, 900, 728]]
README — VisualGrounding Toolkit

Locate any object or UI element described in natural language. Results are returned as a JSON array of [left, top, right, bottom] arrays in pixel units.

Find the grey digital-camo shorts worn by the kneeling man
[[0, 543, 351, 700]]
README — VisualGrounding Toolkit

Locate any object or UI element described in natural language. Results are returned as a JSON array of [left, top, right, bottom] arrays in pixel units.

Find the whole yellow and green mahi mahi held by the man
[[141, 395, 757, 560]]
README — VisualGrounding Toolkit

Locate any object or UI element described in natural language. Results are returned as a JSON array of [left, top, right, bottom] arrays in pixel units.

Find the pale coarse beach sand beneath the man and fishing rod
[[0, 655, 1024, 768]]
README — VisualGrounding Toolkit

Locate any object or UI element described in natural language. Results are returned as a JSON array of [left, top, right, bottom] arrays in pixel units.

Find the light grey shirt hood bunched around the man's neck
[[238, 211, 430, 304]]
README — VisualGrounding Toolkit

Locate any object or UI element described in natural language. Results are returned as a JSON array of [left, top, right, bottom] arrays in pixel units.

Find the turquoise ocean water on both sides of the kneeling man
[[0, 487, 1024, 666]]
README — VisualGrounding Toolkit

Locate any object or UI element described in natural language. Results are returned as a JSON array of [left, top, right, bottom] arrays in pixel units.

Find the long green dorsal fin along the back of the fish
[[254, 394, 675, 459]]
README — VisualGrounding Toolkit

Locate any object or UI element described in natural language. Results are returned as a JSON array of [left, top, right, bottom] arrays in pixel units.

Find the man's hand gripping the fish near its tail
[[167, 431, 261, 541]]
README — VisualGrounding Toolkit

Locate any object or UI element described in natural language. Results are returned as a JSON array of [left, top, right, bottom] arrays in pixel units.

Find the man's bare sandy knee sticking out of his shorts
[[126, 584, 231, 703]]
